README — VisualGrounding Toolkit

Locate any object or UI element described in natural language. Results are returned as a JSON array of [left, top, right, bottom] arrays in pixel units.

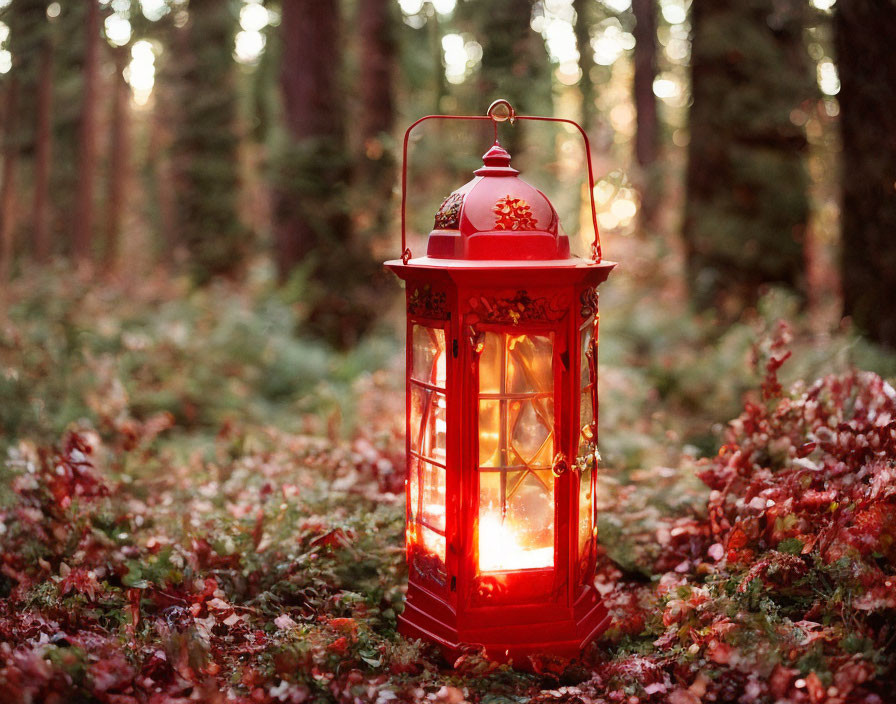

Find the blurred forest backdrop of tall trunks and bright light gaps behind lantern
[[0, 0, 894, 347]]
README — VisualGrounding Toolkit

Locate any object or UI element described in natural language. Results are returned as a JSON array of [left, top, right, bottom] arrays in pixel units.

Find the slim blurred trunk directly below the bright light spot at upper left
[[103, 46, 130, 270]]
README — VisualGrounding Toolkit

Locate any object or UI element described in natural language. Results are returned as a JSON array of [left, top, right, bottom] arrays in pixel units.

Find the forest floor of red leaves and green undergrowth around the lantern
[[0, 269, 896, 704]]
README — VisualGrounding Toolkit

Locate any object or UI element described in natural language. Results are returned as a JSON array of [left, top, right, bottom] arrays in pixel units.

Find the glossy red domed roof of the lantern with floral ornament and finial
[[427, 141, 570, 261]]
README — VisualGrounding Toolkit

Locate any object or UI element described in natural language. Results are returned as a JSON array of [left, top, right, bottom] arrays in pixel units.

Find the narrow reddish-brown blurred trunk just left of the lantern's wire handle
[[357, 0, 397, 240]]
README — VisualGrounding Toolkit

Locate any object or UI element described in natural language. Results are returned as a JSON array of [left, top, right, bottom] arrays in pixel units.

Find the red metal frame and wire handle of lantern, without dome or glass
[[385, 101, 615, 666]]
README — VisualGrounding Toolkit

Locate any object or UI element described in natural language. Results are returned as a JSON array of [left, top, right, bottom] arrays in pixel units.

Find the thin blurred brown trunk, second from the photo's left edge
[[31, 34, 53, 262]]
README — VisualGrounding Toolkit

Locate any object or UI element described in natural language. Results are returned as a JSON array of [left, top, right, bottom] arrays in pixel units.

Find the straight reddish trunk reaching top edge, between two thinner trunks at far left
[[73, 0, 101, 260]]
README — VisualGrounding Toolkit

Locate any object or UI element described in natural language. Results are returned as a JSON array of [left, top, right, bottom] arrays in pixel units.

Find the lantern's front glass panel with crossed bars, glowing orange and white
[[479, 332, 555, 572]]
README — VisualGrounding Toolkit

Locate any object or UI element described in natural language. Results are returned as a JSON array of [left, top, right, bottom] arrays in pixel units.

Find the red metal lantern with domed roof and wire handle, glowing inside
[[386, 101, 615, 662]]
